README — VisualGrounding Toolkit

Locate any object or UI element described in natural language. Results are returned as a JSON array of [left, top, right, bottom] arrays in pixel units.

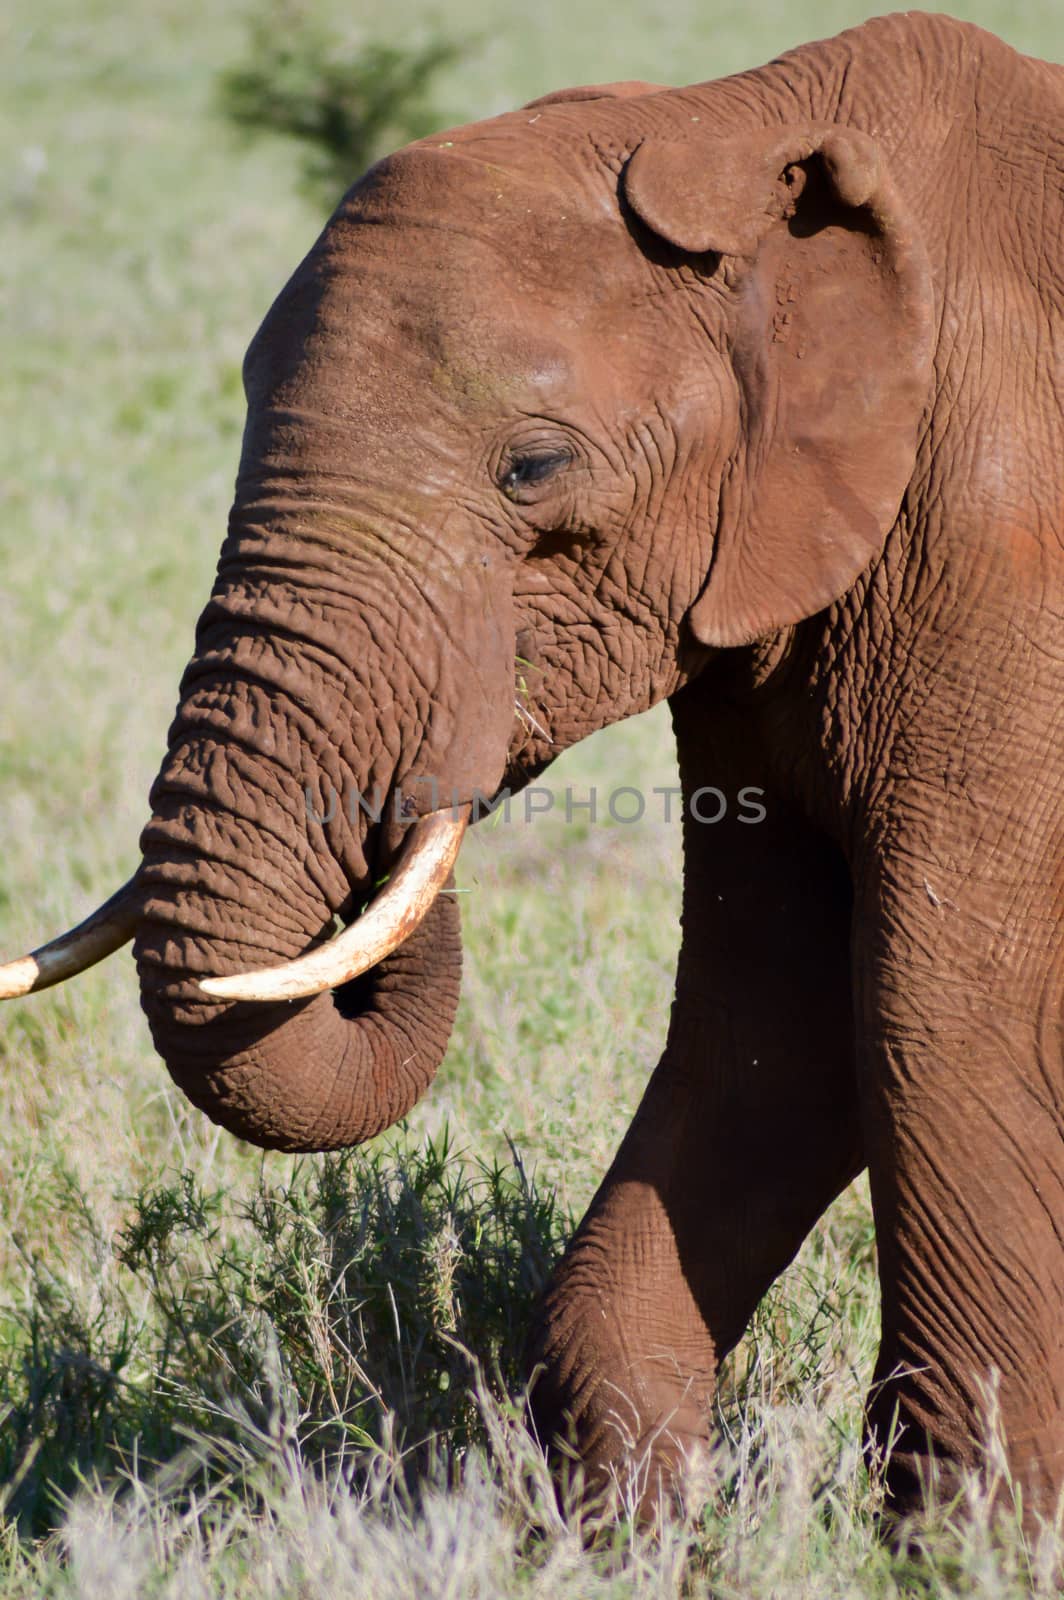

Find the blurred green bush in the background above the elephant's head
[[221, 0, 470, 206]]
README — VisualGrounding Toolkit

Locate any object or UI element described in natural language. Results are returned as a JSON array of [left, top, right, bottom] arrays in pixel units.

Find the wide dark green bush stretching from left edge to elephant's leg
[[0, 1133, 571, 1533]]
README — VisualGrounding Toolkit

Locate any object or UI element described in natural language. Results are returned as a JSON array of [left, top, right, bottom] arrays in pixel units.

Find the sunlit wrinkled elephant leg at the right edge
[[854, 844, 1064, 1520]]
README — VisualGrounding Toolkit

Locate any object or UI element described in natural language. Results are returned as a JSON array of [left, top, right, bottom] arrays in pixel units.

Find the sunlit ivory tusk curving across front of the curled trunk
[[200, 806, 470, 1000]]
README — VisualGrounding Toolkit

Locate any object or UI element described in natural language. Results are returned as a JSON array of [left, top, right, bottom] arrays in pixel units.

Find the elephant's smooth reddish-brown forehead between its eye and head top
[[245, 147, 656, 456]]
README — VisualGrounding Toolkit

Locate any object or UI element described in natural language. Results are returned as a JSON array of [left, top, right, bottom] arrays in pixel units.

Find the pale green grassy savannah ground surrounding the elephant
[[0, 0, 1062, 1600]]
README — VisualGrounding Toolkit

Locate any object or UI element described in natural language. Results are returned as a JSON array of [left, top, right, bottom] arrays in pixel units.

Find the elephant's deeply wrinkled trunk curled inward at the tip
[[134, 518, 512, 1150]]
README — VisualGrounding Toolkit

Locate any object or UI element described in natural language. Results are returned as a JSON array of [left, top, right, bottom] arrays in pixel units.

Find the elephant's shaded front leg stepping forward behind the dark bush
[[530, 728, 864, 1512]]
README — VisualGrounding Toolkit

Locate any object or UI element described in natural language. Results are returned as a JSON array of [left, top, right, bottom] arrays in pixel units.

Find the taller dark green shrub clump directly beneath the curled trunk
[[235, 1133, 560, 1450]]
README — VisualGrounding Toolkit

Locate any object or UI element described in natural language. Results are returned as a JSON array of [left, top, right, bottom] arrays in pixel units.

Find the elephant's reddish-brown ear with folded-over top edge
[[624, 125, 933, 646]]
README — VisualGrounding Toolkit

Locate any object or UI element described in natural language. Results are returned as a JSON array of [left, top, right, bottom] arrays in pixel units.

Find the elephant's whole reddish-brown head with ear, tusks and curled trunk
[[0, 85, 931, 1149]]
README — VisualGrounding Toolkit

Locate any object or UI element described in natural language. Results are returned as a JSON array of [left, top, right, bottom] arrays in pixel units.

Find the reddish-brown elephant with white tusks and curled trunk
[[0, 13, 1064, 1517]]
